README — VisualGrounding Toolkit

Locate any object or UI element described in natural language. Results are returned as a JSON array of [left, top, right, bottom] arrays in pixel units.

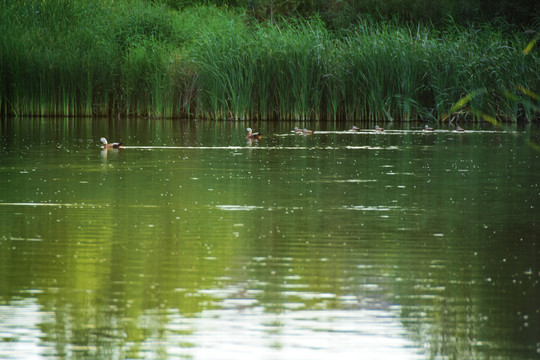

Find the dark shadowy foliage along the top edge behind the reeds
[[158, 0, 540, 29]]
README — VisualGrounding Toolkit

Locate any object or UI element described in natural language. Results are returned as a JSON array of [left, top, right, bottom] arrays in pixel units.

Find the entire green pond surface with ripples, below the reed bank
[[0, 119, 540, 359]]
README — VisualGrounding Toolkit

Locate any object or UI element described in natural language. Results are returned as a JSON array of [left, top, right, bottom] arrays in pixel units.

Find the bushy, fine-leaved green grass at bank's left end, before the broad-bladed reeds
[[0, 0, 192, 116]]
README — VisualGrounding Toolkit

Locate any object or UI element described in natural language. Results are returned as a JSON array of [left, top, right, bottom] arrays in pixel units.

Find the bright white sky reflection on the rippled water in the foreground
[[0, 298, 422, 359]]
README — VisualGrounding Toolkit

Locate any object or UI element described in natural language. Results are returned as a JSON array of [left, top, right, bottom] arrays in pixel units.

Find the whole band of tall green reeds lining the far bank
[[0, 0, 540, 121]]
